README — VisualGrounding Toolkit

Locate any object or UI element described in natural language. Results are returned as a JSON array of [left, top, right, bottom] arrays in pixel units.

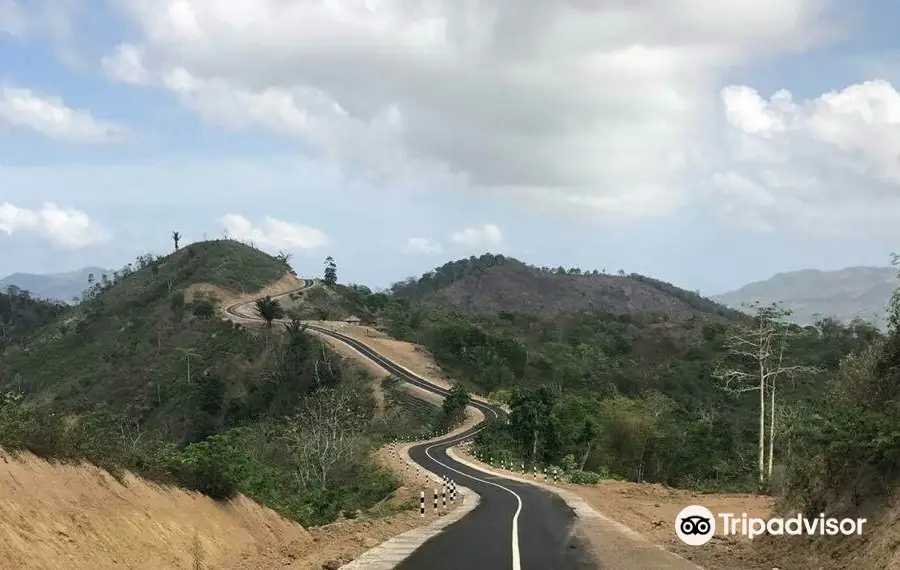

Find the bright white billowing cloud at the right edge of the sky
[[712, 81, 900, 234]]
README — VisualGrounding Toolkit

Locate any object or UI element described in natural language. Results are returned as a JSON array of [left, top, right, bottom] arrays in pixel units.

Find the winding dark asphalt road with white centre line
[[225, 280, 597, 570]]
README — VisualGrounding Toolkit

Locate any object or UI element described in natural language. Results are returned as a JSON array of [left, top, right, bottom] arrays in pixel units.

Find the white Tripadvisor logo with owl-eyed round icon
[[675, 505, 866, 546]]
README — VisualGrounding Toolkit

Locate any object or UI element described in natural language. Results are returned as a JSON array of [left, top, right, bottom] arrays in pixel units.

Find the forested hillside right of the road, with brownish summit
[[338, 251, 881, 489]]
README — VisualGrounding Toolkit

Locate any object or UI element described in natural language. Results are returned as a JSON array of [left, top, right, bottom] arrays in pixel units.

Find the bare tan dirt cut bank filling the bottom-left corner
[[0, 452, 313, 570]]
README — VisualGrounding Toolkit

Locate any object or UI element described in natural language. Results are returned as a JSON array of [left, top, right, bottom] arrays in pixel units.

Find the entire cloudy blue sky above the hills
[[0, 0, 900, 294]]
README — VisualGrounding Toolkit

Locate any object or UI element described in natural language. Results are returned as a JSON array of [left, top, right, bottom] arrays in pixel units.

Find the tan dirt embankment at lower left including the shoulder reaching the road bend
[[0, 449, 478, 570]]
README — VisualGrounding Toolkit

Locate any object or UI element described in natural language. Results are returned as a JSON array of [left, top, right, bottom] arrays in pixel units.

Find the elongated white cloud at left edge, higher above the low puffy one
[[0, 87, 128, 143]]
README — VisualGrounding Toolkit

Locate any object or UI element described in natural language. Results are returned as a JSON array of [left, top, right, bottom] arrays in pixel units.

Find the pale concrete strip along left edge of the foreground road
[[340, 444, 481, 570]]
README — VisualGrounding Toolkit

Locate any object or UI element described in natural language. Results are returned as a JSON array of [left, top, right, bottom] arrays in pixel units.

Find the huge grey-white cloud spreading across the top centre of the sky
[[104, 0, 831, 218]]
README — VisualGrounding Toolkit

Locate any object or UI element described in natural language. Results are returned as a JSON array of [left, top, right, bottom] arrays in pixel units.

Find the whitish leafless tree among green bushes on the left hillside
[[283, 389, 365, 489]]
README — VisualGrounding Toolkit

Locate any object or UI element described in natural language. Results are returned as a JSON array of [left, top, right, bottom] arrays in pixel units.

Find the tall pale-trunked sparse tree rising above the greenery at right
[[713, 302, 817, 484]]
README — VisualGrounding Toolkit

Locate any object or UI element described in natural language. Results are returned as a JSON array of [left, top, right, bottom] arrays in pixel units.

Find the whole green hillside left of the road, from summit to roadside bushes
[[0, 240, 440, 525]]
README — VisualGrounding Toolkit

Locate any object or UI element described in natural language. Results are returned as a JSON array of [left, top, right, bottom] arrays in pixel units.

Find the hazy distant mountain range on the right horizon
[[710, 267, 900, 328]]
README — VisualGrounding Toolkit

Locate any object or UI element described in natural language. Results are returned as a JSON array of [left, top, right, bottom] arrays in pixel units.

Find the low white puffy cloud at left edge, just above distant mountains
[[0, 202, 110, 249]]
